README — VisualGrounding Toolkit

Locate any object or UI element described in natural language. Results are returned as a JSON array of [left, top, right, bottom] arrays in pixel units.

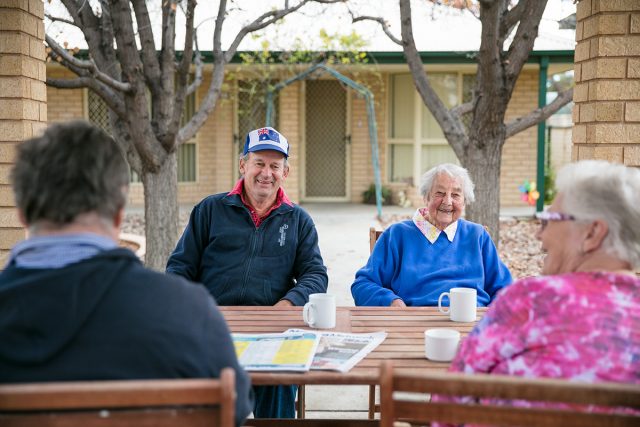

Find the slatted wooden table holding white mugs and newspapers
[[220, 306, 486, 425]]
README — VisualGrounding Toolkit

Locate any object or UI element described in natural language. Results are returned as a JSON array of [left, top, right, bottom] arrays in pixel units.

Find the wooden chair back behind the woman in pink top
[[380, 361, 640, 427]]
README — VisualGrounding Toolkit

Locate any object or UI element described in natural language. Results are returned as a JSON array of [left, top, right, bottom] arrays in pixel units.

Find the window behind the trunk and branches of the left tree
[[87, 89, 197, 182]]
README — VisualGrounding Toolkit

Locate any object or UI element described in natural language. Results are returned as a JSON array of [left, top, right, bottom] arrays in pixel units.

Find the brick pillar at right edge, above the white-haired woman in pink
[[572, 0, 640, 166]]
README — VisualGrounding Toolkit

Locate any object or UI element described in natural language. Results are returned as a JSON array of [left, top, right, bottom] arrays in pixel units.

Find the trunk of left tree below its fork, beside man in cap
[[142, 152, 178, 271]]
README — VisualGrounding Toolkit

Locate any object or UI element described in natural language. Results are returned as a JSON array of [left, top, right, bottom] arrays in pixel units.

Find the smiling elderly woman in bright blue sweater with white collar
[[351, 163, 512, 307]]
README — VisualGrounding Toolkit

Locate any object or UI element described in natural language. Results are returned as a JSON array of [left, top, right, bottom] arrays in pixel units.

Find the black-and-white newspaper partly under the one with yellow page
[[286, 329, 387, 372]]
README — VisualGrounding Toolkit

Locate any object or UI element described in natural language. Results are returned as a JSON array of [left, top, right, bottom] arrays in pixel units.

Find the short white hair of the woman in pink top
[[556, 160, 640, 269]]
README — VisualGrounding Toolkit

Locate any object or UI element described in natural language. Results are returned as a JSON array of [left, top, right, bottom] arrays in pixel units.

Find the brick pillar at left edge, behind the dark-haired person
[[0, 0, 47, 268]]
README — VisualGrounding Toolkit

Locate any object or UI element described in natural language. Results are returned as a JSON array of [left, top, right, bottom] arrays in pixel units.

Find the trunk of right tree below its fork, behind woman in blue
[[463, 137, 504, 246]]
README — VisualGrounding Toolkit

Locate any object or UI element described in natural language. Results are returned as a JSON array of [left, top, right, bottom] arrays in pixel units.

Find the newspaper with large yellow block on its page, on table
[[233, 330, 320, 372]]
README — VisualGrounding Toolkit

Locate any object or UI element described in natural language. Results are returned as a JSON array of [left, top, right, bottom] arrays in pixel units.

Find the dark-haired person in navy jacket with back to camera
[[0, 122, 252, 425]]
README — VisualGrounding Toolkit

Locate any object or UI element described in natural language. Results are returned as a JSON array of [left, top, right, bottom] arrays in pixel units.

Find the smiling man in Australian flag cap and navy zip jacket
[[167, 127, 328, 418]]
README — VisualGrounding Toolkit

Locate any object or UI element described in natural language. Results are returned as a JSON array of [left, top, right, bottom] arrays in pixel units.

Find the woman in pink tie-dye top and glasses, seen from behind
[[441, 160, 640, 392]]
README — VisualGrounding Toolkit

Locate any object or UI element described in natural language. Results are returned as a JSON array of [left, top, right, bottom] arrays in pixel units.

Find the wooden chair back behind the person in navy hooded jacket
[[0, 368, 236, 427]]
